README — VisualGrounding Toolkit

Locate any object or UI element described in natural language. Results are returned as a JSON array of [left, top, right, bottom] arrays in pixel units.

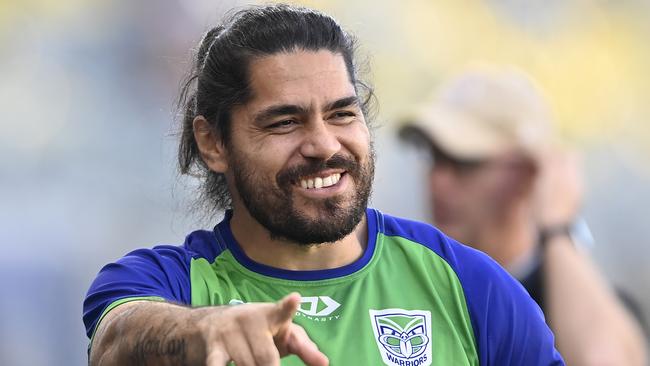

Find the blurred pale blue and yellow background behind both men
[[0, 0, 650, 365]]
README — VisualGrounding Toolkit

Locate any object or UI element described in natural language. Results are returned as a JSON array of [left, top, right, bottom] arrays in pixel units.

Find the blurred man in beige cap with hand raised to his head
[[401, 68, 645, 365]]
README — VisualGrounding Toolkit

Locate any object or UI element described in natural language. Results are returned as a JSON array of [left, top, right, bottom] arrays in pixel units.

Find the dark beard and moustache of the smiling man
[[231, 146, 375, 246]]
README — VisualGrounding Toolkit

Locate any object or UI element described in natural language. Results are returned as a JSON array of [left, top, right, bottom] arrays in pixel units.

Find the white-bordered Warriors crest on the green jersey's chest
[[369, 309, 432, 366]]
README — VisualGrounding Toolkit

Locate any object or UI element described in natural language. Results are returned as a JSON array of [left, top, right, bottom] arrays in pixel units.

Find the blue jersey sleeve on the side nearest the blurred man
[[441, 236, 564, 366]]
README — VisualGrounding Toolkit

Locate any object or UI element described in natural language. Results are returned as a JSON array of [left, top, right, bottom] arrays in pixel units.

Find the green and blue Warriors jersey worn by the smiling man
[[84, 208, 564, 366]]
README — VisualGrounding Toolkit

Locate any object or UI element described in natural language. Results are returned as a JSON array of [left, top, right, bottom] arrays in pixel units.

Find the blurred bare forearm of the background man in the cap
[[545, 236, 646, 366]]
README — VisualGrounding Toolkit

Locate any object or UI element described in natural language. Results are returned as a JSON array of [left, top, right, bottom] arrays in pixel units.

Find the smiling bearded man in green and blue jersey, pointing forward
[[84, 5, 563, 366]]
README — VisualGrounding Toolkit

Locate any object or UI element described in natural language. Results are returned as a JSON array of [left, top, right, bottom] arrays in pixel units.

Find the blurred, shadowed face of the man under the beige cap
[[429, 149, 519, 246]]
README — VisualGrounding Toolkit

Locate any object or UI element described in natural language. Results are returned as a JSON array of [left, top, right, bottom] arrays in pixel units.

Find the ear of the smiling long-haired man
[[192, 116, 228, 173]]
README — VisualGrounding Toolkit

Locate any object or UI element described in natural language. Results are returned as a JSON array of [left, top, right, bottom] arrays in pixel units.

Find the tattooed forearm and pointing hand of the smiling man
[[90, 293, 328, 366]]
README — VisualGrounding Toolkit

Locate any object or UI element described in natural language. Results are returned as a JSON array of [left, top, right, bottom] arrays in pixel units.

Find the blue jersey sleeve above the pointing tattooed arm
[[83, 245, 192, 337]]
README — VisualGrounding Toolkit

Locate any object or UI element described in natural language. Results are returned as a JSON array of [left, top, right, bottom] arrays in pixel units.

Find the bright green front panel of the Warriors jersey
[[190, 234, 478, 365]]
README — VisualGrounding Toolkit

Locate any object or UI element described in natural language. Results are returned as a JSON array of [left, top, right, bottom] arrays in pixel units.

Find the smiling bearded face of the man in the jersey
[[226, 47, 374, 245]]
